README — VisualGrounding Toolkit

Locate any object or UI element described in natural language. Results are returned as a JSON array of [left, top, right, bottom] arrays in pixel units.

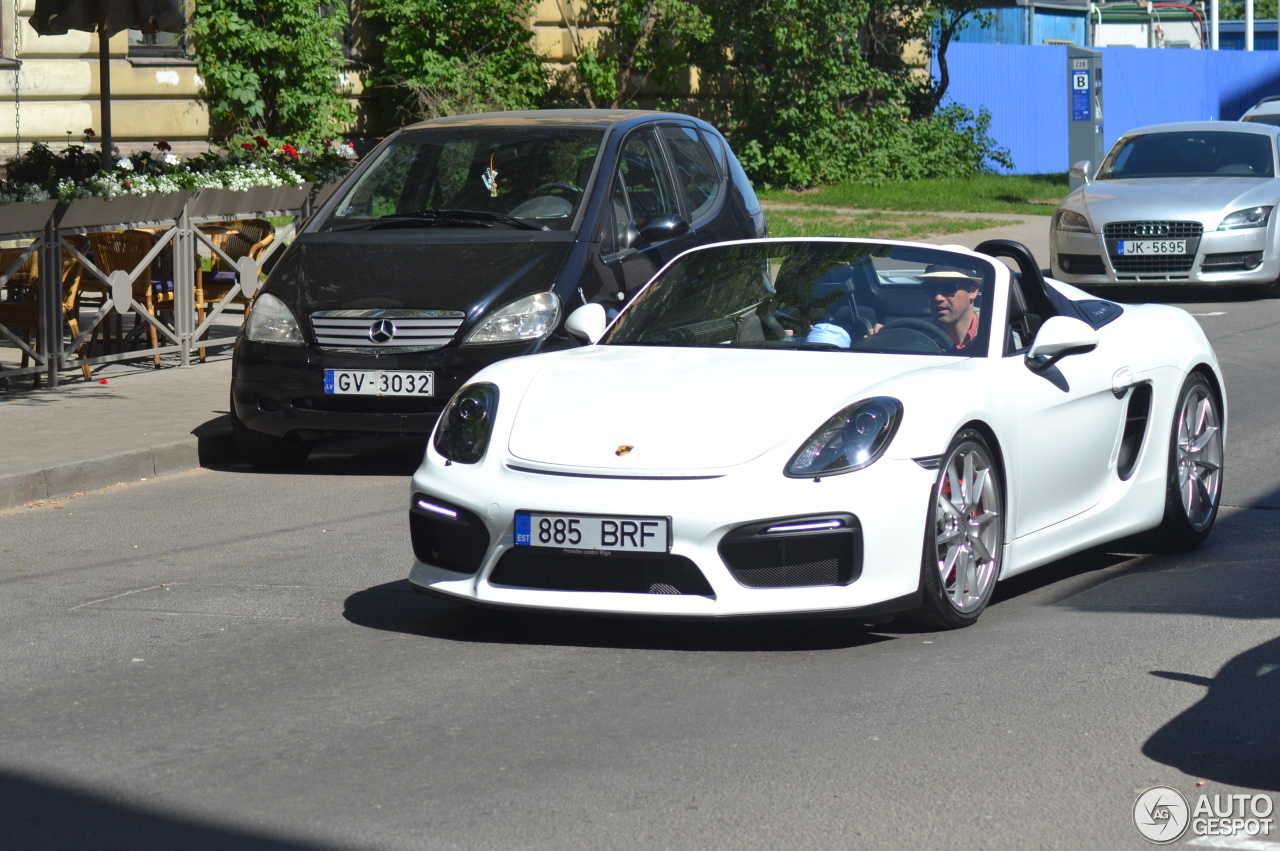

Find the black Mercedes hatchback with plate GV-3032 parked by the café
[[232, 110, 765, 466]]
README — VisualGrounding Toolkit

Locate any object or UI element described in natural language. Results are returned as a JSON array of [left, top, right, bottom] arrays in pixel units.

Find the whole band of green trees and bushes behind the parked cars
[[192, 0, 1012, 187]]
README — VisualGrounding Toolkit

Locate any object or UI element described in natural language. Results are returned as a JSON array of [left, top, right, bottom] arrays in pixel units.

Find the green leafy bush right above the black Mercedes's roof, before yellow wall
[[364, 0, 547, 122]]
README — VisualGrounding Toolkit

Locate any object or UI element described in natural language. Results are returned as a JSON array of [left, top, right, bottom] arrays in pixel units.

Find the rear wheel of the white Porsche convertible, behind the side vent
[[1158, 372, 1224, 552]]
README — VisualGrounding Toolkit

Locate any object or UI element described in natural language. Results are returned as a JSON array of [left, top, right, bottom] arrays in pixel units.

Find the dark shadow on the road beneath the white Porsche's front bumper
[[343, 581, 891, 653]]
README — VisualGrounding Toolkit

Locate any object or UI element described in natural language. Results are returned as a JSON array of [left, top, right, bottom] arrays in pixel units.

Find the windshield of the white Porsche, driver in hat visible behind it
[[600, 239, 993, 356]]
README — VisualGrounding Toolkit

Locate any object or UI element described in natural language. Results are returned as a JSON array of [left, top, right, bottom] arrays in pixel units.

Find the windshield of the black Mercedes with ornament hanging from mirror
[[321, 125, 604, 230]]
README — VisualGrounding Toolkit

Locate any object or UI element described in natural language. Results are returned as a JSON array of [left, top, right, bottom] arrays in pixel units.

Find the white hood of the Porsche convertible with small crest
[[502, 346, 954, 475]]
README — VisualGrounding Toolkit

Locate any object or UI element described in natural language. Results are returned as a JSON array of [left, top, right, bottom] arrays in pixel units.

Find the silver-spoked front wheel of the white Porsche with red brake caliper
[[911, 430, 1005, 630]]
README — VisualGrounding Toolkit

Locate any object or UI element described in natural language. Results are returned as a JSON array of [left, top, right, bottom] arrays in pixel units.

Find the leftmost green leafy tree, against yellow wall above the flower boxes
[[187, 0, 355, 146]]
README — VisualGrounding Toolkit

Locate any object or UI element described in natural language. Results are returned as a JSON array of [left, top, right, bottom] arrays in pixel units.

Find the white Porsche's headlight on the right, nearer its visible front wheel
[[787, 395, 902, 479]]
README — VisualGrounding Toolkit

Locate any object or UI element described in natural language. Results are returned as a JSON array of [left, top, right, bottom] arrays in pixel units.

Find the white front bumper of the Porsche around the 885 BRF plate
[[408, 449, 936, 618]]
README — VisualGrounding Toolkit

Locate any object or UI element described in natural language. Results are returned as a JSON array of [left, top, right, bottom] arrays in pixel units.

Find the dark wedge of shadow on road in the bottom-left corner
[[0, 772, 332, 851]]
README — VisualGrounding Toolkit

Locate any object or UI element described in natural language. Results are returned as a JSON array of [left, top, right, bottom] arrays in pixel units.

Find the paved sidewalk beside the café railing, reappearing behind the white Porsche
[[0, 215, 1048, 511]]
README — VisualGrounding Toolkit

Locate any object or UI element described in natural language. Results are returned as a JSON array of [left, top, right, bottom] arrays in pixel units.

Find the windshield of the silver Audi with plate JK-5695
[[1098, 131, 1275, 180]]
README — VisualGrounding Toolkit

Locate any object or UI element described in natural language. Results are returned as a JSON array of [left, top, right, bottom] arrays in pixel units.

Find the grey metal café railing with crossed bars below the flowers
[[0, 183, 333, 386]]
